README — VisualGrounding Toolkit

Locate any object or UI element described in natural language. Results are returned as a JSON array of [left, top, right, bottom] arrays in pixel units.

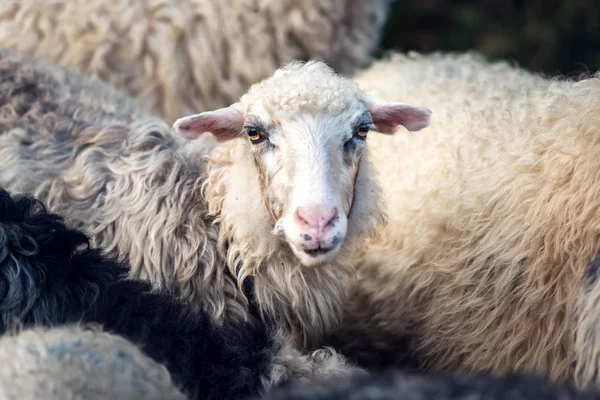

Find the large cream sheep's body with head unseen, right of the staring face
[[326, 53, 600, 384]]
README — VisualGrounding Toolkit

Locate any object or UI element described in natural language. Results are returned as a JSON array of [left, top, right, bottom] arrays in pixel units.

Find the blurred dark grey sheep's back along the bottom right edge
[[257, 370, 600, 400]]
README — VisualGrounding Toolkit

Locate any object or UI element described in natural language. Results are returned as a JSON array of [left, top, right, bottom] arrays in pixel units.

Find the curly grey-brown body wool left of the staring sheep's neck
[[0, 50, 231, 320]]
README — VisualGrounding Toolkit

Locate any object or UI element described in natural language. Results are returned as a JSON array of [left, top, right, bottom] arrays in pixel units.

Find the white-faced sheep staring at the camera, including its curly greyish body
[[0, 46, 430, 348]]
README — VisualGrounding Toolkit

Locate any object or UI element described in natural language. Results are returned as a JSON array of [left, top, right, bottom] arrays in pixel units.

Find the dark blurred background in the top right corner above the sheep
[[378, 0, 600, 77]]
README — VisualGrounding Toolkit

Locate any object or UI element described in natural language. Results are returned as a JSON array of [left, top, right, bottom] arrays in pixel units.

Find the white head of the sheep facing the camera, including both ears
[[174, 62, 430, 266]]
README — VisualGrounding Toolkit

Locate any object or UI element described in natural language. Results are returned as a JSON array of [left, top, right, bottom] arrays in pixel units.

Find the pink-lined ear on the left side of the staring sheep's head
[[173, 103, 244, 142]]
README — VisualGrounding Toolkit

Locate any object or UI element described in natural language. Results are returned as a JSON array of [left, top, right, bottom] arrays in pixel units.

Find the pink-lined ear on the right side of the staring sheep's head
[[365, 97, 431, 134]]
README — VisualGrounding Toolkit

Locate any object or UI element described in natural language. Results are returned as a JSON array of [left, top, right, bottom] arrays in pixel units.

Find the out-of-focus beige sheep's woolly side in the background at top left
[[0, 0, 392, 122]]
